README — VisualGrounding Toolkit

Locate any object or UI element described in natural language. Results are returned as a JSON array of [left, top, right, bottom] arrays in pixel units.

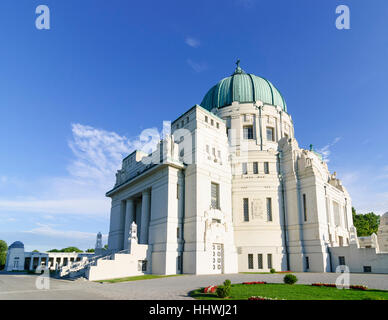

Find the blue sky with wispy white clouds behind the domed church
[[0, 0, 388, 250]]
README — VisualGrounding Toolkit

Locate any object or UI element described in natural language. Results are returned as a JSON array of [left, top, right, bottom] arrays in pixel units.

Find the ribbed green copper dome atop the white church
[[201, 60, 287, 111]]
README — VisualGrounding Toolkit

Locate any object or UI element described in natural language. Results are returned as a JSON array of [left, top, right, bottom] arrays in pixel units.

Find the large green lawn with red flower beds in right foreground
[[190, 283, 388, 300]]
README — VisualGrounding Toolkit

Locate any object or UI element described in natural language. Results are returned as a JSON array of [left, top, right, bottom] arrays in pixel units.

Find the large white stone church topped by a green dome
[[97, 61, 353, 277]]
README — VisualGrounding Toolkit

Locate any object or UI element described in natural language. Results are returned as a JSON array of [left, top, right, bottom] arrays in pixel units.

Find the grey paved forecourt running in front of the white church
[[0, 273, 388, 300]]
